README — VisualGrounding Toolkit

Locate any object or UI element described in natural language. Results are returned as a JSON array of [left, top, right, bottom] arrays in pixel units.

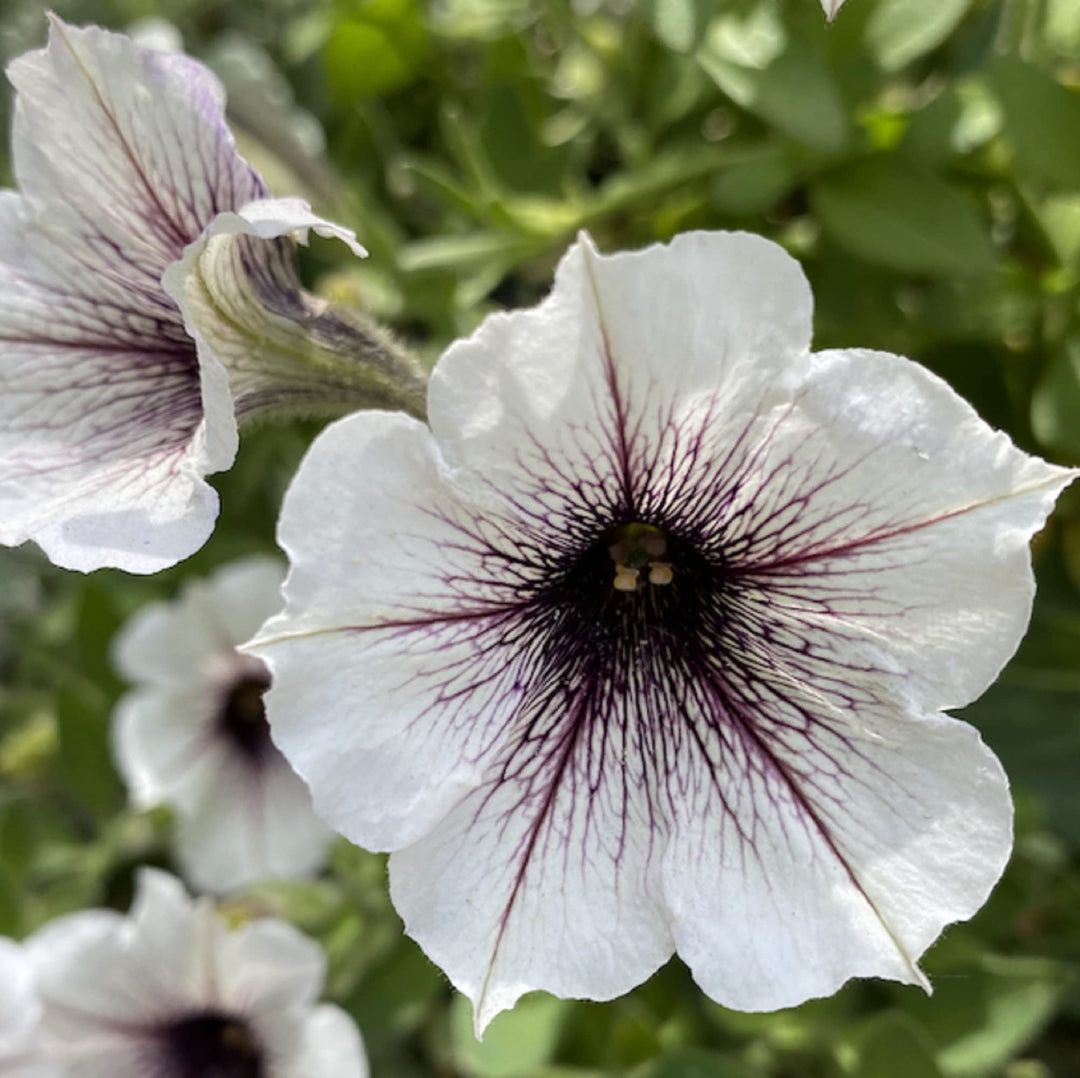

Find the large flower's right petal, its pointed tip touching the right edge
[[730, 351, 1077, 710]]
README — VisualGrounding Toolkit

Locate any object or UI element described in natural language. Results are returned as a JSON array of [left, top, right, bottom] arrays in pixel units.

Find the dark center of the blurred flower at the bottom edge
[[160, 1011, 268, 1078]]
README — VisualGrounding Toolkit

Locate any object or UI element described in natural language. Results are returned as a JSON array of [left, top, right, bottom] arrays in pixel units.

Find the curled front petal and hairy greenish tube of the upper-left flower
[[163, 199, 423, 421]]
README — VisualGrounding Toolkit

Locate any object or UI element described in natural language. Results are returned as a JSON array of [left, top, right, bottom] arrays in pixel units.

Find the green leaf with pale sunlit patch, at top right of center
[[697, 17, 849, 154]]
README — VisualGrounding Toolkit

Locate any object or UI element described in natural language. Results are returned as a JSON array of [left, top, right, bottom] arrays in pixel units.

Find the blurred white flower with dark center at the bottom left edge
[[26, 868, 367, 1078]]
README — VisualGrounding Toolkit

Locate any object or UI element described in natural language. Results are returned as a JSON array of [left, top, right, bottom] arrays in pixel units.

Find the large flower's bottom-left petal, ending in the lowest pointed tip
[[390, 670, 674, 1036]]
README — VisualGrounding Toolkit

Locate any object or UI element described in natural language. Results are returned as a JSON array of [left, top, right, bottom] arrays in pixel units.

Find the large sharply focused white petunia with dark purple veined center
[[245, 232, 1072, 1028]]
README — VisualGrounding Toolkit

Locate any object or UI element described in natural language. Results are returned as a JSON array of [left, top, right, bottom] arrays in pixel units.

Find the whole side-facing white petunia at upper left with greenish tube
[[0, 17, 422, 572]]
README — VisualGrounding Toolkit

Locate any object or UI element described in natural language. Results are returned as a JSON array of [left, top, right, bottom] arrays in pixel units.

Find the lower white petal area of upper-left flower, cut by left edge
[[0, 192, 227, 572]]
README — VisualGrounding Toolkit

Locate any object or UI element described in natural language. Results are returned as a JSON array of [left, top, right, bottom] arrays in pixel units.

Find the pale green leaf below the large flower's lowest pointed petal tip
[[450, 993, 569, 1078]]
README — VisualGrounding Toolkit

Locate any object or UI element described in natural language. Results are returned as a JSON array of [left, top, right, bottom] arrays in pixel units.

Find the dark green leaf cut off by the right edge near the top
[[990, 56, 1080, 188]]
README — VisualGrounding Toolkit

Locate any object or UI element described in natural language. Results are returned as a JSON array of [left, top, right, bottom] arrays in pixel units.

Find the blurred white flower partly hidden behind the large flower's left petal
[[112, 557, 333, 892]]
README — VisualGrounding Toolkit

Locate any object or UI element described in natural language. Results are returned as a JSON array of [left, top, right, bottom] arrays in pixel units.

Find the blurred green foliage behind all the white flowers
[[0, 0, 1080, 1078]]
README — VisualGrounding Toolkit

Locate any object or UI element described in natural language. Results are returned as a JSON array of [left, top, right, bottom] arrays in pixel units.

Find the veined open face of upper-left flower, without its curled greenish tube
[[0, 18, 266, 572]]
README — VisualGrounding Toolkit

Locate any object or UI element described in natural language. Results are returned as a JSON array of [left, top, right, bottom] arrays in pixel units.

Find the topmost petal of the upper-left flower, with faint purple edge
[[8, 17, 265, 274]]
